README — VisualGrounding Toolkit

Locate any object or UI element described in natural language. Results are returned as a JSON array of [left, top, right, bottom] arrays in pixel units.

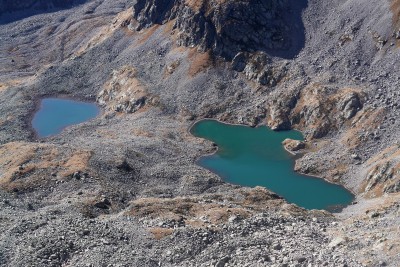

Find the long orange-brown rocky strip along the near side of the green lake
[[127, 187, 302, 228]]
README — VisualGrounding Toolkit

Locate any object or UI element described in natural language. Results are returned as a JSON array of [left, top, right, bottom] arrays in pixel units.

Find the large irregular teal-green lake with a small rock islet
[[190, 120, 354, 212]]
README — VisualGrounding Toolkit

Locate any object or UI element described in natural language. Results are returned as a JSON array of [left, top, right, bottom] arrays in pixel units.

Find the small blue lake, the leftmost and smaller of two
[[32, 98, 100, 137]]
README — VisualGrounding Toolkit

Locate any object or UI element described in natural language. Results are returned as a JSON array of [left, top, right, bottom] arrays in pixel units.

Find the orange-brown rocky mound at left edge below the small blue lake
[[0, 142, 92, 193]]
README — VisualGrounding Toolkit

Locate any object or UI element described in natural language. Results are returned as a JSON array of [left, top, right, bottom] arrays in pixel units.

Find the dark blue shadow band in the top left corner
[[0, 0, 88, 25]]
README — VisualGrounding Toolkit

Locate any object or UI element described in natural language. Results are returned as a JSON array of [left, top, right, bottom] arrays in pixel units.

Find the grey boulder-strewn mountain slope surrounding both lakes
[[0, 0, 400, 267]]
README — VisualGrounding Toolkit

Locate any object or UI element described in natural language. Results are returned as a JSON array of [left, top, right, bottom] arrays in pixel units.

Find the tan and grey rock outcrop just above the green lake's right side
[[267, 85, 364, 138]]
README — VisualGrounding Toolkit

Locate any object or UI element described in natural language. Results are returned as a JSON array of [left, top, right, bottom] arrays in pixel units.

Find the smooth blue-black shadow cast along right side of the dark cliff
[[265, 0, 308, 59]]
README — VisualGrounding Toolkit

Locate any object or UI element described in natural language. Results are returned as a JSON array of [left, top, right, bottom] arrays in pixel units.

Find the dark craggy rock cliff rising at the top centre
[[133, 0, 291, 59]]
